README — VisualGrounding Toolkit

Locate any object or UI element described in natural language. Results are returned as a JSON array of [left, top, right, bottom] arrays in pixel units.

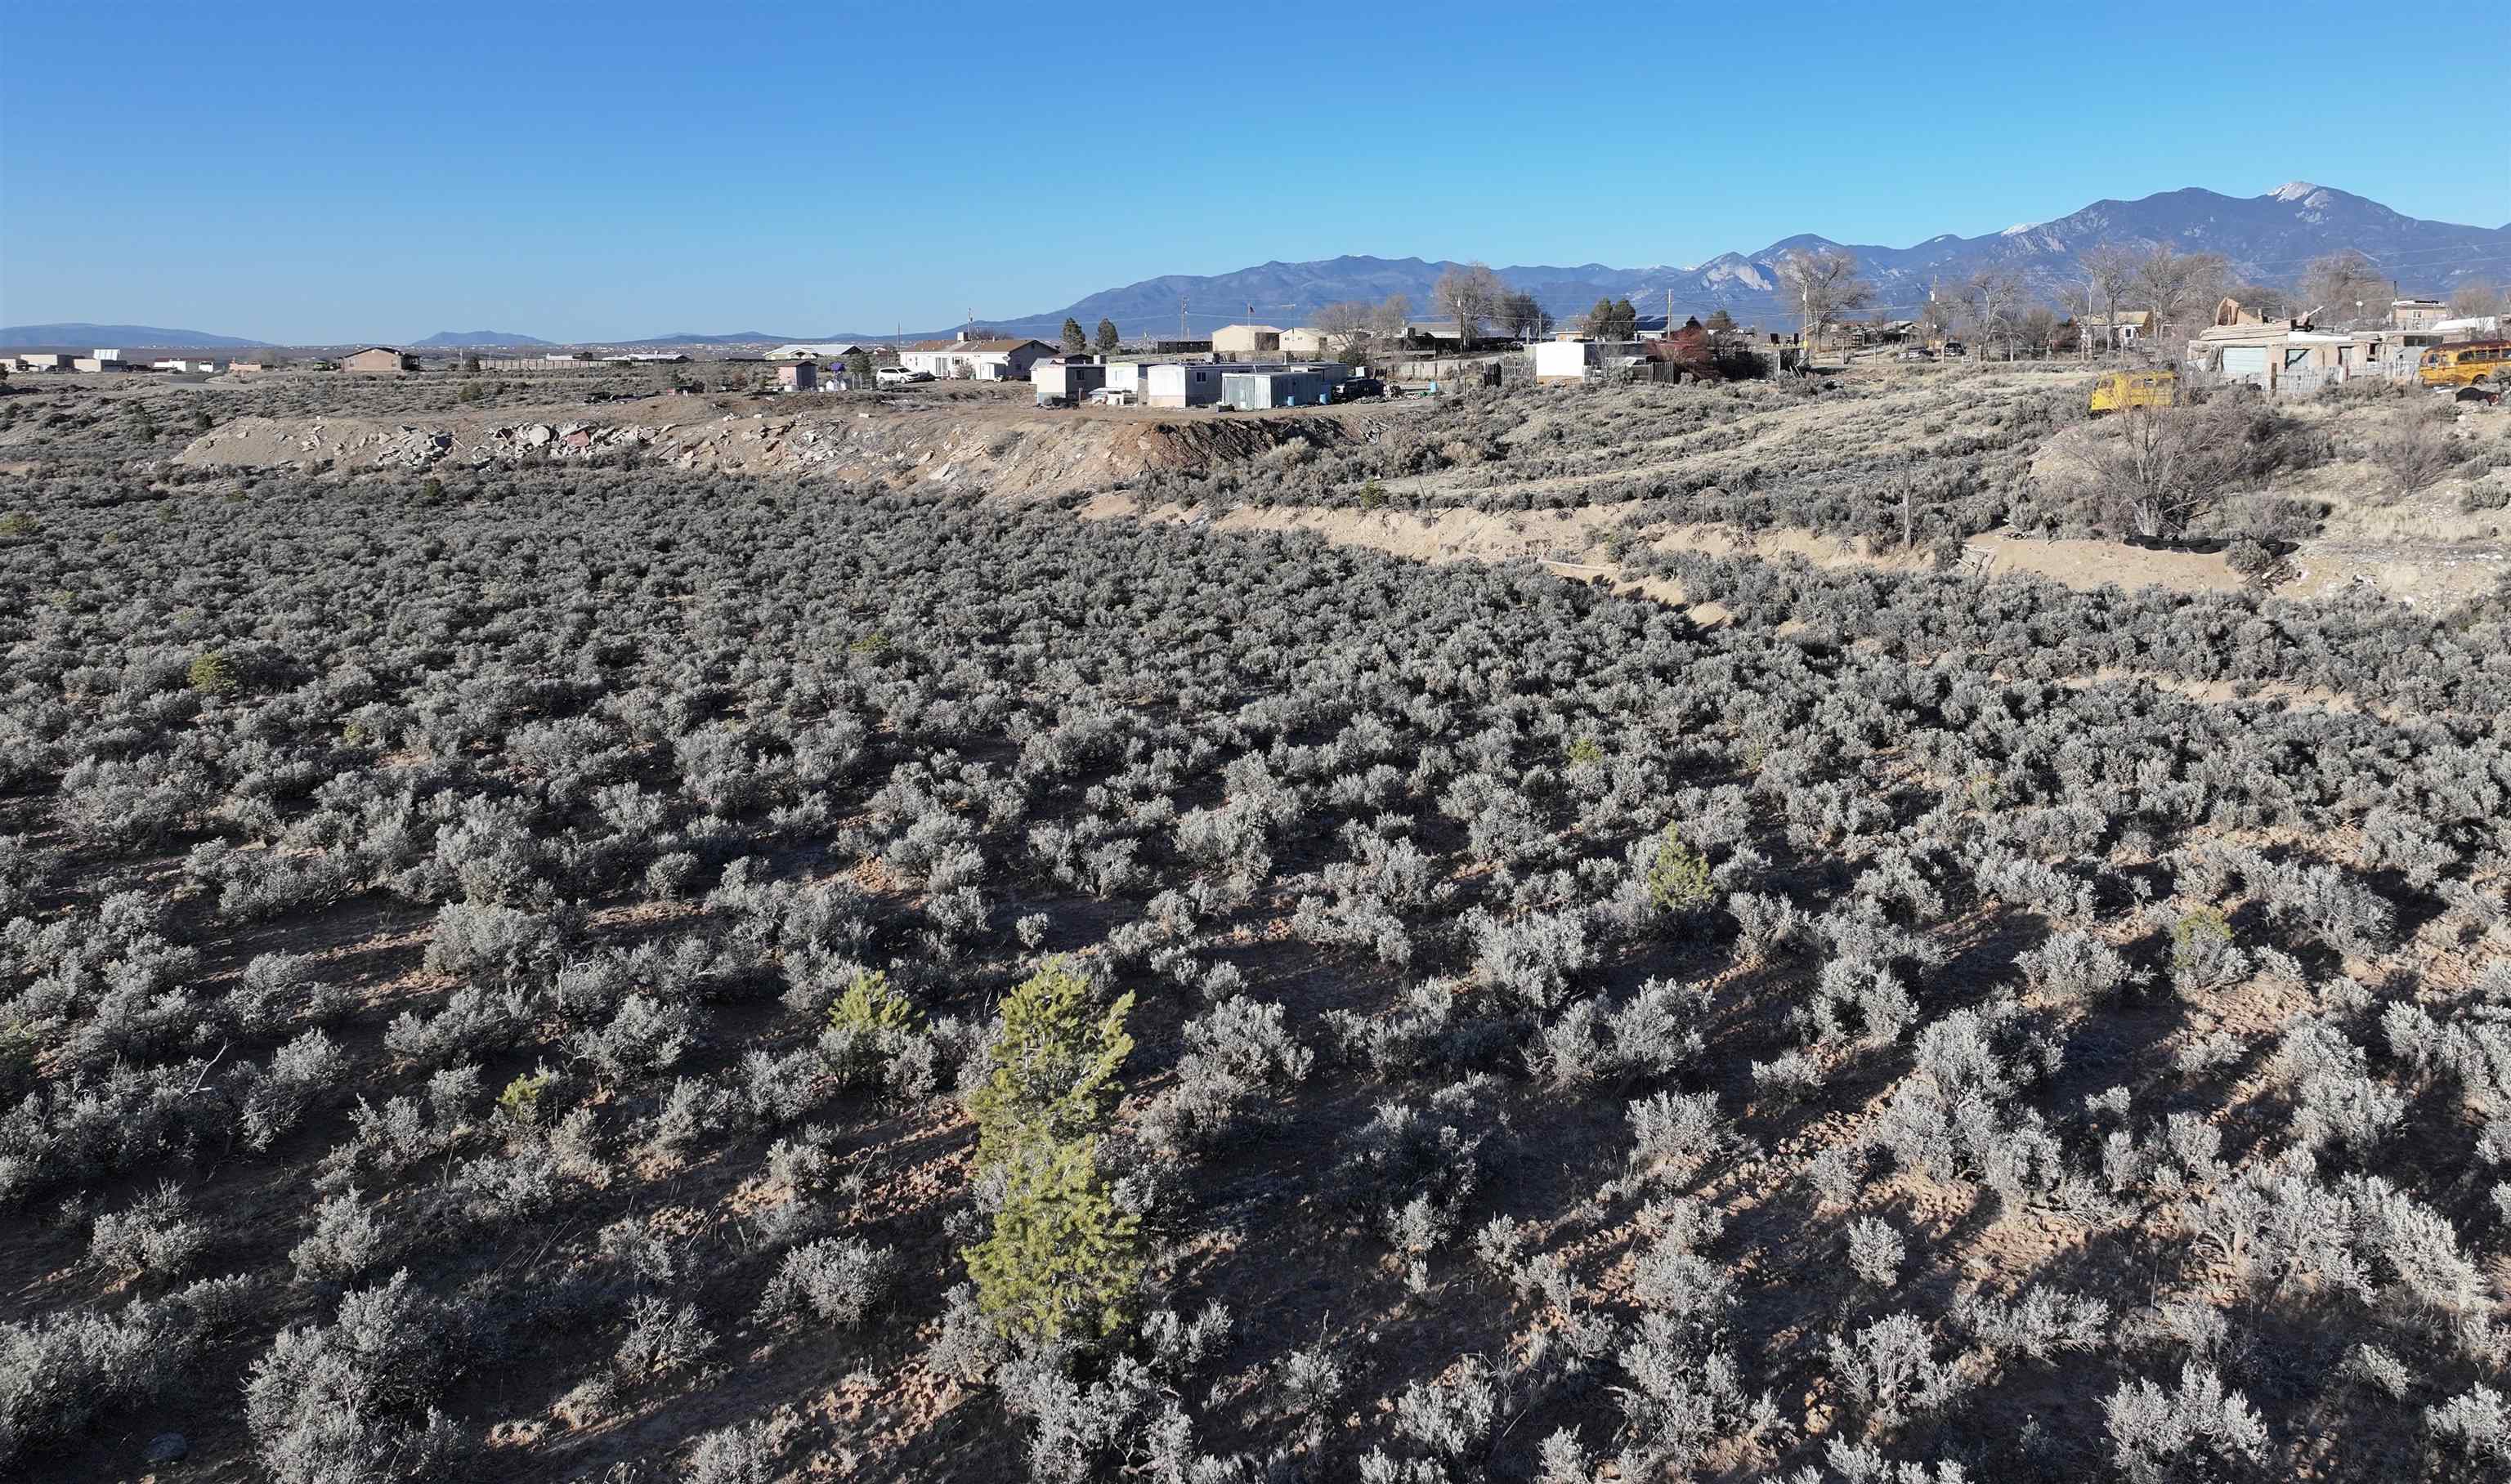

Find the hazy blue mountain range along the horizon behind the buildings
[[15, 181, 2511, 349]]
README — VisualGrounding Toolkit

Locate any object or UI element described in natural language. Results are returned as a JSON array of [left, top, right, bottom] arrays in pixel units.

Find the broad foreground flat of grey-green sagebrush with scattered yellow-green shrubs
[[0, 457, 2511, 1484]]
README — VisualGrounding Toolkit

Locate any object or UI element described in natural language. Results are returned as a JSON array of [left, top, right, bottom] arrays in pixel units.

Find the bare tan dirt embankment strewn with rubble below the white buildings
[[176, 396, 1351, 497]]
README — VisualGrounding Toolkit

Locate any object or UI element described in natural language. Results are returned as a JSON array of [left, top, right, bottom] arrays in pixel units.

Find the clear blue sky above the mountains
[[0, 0, 2511, 342]]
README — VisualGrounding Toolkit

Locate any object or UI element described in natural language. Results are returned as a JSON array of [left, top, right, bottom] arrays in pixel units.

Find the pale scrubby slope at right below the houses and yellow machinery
[[1130, 364, 2511, 574]]
